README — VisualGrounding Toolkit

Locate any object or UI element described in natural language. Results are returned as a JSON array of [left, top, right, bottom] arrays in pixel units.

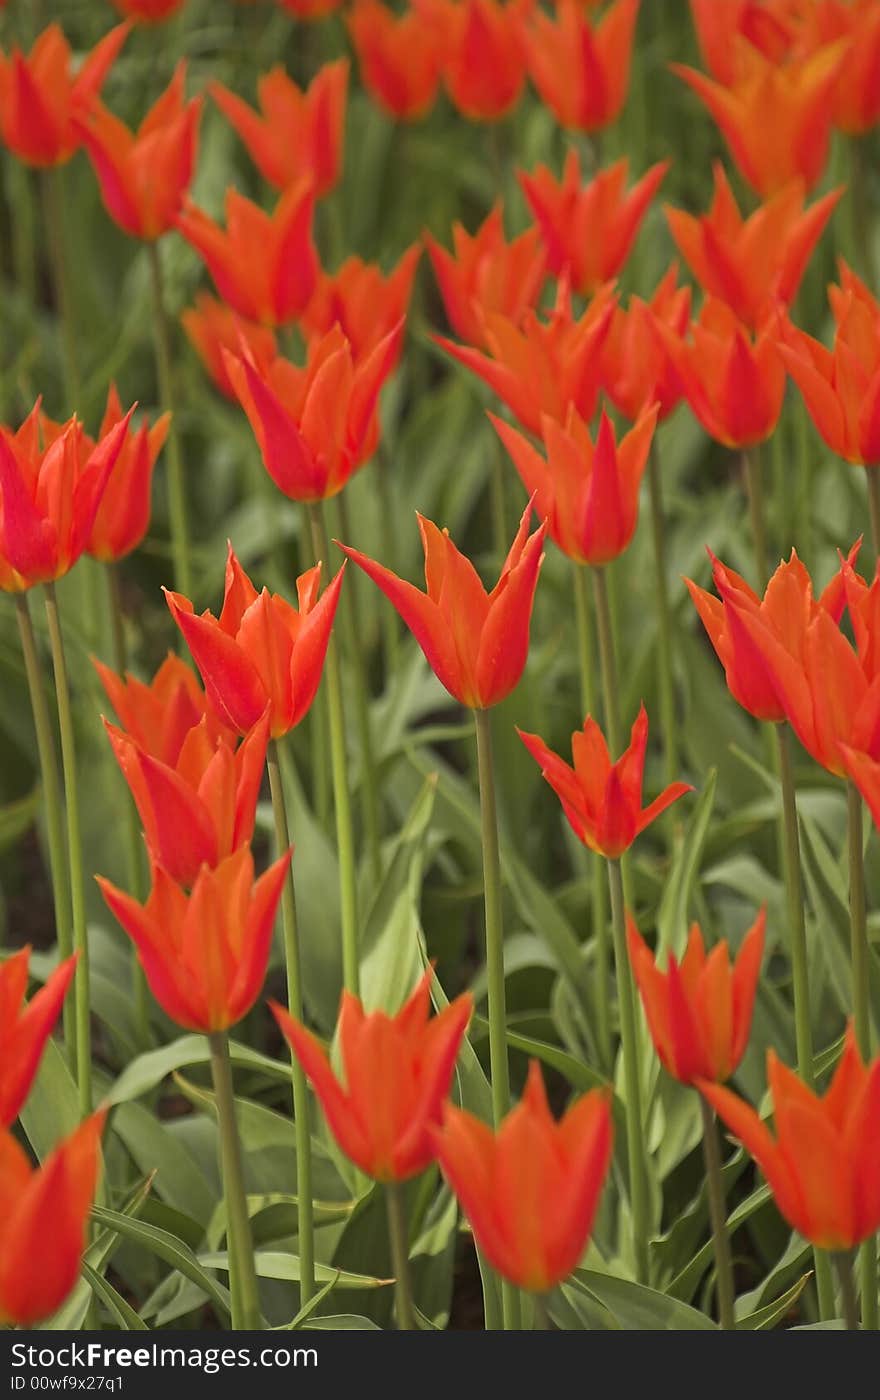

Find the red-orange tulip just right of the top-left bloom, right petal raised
[[77, 62, 201, 241]]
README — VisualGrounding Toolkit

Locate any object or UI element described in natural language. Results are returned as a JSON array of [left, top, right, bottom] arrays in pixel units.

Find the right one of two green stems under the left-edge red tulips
[[43, 582, 92, 1117]]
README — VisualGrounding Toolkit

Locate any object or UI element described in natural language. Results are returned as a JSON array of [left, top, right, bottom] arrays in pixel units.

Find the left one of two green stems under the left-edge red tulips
[[14, 594, 77, 1058]]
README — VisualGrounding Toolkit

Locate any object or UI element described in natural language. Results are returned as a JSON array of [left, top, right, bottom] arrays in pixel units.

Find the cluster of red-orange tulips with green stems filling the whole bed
[[0, 0, 880, 1329]]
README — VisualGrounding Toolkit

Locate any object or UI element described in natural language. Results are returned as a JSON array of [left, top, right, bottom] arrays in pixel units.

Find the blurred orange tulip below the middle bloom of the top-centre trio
[[425, 202, 547, 346]]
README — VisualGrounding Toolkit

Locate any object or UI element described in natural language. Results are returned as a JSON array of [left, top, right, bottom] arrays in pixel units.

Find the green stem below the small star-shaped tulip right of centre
[[607, 860, 648, 1284]]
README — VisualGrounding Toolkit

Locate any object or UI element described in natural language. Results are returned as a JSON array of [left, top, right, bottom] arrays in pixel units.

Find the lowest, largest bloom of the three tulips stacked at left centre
[[97, 846, 291, 1035]]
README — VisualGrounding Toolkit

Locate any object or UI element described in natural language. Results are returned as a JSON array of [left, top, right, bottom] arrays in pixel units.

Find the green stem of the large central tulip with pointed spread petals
[[474, 710, 520, 1331]]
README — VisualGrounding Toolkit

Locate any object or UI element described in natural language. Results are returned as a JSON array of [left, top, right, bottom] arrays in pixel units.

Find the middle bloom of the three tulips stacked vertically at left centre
[[104, 713, 269, 885]]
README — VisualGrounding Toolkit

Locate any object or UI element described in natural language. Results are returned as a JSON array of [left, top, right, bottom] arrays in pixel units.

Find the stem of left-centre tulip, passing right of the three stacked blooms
[[266, 739, 315, 1308]]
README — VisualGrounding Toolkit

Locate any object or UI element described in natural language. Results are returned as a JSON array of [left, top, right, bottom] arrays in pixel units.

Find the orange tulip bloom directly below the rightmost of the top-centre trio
[[518, 150, 669, 295]]
